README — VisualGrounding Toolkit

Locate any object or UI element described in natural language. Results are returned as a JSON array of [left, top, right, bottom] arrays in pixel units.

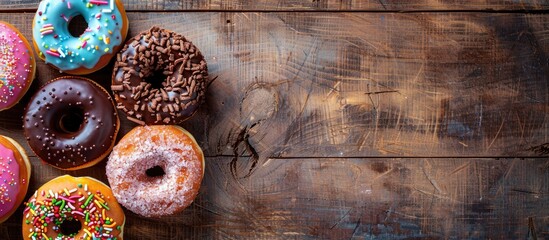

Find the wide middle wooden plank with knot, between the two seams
[[0, 13, 549, 159]]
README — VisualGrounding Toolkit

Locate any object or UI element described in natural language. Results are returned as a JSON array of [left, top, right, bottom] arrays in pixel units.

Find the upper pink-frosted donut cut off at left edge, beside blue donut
[[0, 21, 36, 111]]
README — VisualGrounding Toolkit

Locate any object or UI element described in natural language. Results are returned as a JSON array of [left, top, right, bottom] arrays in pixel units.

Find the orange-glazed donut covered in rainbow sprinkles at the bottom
[[22, 175, 126, 239]]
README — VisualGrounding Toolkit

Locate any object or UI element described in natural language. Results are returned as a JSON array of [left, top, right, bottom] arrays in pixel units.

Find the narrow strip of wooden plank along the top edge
[[0, 0, 549, 11]]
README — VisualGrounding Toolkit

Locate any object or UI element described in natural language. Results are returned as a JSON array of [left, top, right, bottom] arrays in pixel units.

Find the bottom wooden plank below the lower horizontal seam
[[0, 157, 549, 239]]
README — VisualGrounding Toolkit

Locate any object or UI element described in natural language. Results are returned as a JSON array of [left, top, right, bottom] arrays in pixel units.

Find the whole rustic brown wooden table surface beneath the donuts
[[0, 0, 549, 239]]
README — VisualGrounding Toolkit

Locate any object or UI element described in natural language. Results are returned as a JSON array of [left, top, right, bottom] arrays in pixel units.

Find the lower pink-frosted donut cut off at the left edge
[[0, 136, 31, 223]]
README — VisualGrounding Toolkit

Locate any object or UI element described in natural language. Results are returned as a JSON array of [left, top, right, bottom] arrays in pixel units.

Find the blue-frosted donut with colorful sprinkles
[[32, 0, 128, 75]]
